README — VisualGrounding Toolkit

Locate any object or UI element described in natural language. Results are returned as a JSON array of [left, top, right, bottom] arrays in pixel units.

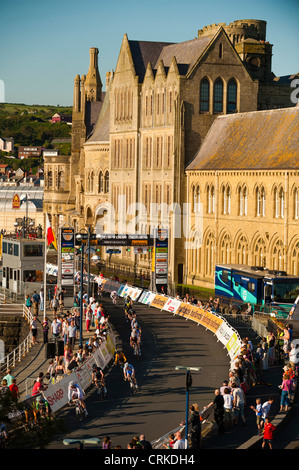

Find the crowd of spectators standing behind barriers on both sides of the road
[[0, 280, 299, 449]]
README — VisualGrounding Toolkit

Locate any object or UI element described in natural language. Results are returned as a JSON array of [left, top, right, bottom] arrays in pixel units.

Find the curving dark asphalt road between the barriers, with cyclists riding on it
[[47, 300, 229, 449]]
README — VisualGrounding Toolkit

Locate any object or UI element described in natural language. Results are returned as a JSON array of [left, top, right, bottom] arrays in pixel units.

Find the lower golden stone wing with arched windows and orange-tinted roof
[[185, 106, 299, 287]]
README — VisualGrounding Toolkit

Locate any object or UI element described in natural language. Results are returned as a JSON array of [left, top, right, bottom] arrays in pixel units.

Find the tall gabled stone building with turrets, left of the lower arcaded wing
[[45, 20, 293, 283]]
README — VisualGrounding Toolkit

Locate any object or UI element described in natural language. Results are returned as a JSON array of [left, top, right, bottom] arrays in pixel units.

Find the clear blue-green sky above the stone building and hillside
[[0, 0, 299, 106]]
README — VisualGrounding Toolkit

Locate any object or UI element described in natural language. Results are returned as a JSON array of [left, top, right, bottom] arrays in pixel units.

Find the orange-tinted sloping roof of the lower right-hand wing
[[186, 106, 299, 171]]
